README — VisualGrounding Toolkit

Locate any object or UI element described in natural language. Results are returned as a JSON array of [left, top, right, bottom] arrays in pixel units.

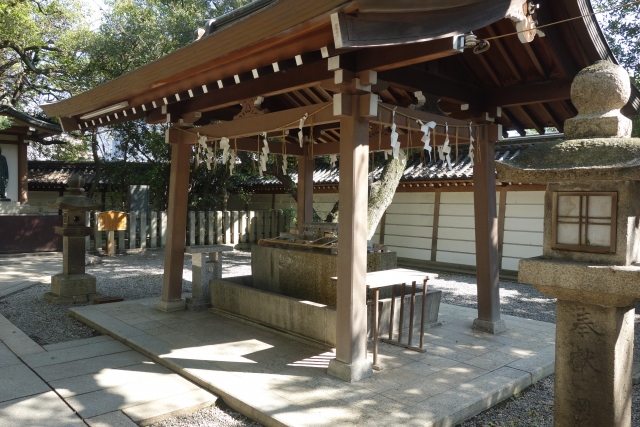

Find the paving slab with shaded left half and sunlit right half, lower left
[[66, 374, 199, 418]]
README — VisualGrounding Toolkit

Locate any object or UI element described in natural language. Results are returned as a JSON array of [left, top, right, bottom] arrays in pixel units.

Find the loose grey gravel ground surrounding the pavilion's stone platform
[[0, 251, 640, 427]]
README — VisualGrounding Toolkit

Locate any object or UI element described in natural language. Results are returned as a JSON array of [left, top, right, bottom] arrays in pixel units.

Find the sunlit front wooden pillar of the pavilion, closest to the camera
[[328, 94, 373, 382]]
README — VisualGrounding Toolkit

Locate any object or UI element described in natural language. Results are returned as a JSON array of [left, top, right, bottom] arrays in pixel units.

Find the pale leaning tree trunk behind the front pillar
[[367, 150, 407, 240]]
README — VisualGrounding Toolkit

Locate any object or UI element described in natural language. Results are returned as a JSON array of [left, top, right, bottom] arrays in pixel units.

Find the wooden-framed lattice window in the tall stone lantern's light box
[[552, 192, 618, 253]]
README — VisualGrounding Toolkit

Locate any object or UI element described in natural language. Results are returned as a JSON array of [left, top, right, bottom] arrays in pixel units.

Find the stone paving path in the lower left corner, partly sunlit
[[0, 316, 217, 427]]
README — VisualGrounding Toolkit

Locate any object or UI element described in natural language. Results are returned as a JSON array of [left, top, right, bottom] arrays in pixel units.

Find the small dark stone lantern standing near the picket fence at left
[[44, 175, 102, 304]]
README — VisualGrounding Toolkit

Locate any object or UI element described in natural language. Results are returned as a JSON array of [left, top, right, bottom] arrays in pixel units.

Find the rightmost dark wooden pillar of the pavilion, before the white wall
[[473, 125, 506, 334]]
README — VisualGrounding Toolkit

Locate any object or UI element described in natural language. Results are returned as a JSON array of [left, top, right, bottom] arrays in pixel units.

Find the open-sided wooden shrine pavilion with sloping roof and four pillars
[[42, 0, 640, 381]]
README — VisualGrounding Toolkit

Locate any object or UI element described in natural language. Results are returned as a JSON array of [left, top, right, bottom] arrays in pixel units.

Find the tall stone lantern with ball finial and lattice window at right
[[498, 61, 640, 427]]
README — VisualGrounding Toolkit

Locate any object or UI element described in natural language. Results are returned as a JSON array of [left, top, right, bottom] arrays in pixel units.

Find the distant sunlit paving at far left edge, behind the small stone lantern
[[0, 254, 62, 298]]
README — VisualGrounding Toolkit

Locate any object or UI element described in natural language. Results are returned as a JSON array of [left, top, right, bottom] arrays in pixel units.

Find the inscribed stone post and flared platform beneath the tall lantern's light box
[[518, 258, 640, 427]]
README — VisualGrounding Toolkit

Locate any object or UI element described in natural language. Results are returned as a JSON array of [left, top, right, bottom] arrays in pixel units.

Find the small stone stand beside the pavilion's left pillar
[[185, 245, 233, 310]]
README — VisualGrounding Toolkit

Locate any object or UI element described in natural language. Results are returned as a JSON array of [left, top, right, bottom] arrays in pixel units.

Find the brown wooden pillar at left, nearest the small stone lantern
[[158, 129, 191, 311]]
